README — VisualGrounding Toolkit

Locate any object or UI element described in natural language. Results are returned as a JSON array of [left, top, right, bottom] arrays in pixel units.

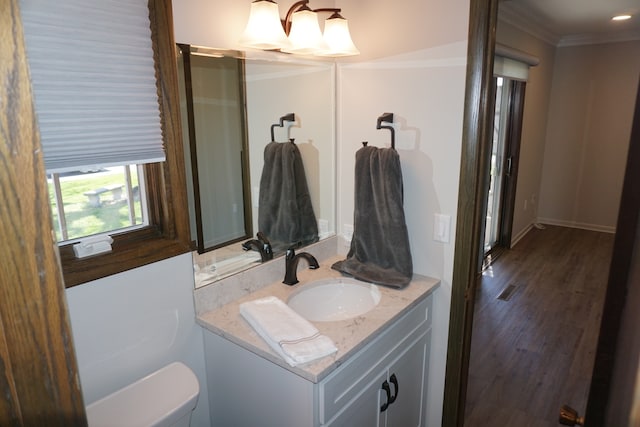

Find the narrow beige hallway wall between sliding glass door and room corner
[[496, 21, 555, 241]]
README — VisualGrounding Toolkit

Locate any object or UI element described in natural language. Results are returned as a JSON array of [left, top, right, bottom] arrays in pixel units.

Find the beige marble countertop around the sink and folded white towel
[[197, 256, 440, 383]]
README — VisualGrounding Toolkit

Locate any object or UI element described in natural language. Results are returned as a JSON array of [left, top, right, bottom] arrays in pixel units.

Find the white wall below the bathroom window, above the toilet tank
[[66, 254, 209, 427]]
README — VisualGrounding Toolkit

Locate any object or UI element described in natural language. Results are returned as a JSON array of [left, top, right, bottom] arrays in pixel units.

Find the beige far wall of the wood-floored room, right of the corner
[[538, 41, 640, 232]]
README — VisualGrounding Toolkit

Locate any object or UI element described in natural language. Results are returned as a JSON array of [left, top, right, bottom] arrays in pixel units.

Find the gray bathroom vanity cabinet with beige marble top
[[198, 258, 439, 427]]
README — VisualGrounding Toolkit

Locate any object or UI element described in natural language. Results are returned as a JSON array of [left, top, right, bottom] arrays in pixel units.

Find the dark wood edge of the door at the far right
[[585, 79, 640, 426]]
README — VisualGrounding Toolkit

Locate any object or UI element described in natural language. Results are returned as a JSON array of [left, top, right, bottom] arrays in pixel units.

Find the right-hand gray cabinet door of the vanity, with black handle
[[384, 333, 429, 427]]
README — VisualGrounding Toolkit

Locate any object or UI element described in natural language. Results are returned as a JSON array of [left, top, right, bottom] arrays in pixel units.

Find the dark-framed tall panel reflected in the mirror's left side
[[178, 45, 253, 253]]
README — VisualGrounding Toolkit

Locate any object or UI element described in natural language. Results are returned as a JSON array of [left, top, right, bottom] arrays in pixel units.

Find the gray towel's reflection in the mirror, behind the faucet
[[258, 142, 318, 252]]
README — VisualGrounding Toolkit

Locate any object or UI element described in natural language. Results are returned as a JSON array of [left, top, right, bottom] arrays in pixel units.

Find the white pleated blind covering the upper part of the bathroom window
[[20, 0, 165, 172]]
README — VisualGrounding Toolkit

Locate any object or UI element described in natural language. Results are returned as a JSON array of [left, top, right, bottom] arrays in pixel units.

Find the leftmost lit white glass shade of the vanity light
[[240, 0, 289, 49]]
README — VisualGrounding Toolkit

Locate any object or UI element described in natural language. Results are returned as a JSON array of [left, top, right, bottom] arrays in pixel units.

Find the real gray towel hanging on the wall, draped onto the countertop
[[331, 147, 413, 288]]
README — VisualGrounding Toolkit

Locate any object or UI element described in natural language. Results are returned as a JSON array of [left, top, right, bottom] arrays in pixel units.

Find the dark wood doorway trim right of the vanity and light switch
[[442, 0, 498, 426]]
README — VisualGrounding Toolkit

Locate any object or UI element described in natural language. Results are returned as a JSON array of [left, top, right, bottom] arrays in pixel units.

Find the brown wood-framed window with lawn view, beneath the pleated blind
[[28, 0, 190, 287]]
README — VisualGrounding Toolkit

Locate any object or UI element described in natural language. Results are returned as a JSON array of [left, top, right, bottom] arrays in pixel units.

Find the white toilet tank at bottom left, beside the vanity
[[87, 362, 200, 427]]
